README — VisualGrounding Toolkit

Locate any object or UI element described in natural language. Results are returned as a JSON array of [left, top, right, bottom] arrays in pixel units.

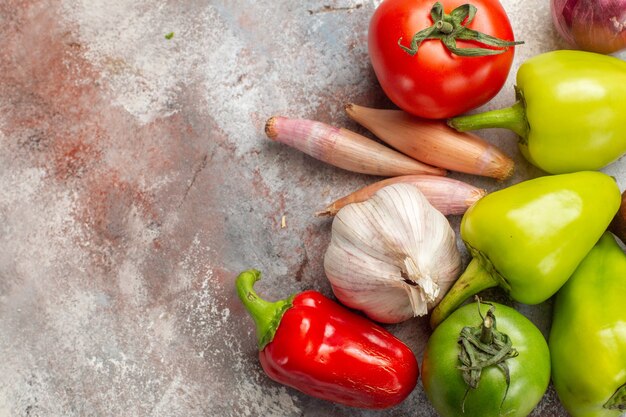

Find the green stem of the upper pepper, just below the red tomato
[[448, 100, 528, 140]]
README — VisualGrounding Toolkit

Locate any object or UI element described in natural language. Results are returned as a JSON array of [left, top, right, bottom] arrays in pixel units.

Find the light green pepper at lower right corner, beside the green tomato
[[550, 233, 626, 417]]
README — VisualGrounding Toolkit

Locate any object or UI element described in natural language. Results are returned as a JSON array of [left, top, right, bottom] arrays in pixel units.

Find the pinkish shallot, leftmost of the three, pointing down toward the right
[[265, 117, 446, 177]]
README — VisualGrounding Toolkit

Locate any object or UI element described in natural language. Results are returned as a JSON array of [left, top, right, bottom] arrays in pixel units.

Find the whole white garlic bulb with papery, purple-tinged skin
[[324, 184, 461, 323]]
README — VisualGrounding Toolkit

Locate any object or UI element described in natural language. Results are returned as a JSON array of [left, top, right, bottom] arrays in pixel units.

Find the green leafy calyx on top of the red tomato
[[398, 2, 524, 57]]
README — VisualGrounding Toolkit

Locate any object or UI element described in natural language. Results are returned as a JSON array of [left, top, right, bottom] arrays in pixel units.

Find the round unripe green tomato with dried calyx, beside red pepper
[[422, 303, 550, 417]]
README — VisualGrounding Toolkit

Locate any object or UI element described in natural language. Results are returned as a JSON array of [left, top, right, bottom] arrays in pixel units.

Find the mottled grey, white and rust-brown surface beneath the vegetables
[[0, 0, 626, 417]]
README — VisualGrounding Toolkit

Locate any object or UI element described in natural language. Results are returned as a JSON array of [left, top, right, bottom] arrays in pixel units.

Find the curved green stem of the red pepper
[[235, 269, 294, 350]]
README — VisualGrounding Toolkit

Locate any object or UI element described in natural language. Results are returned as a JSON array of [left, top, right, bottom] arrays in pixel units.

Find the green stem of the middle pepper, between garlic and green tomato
[[430, 258, 498, 329]]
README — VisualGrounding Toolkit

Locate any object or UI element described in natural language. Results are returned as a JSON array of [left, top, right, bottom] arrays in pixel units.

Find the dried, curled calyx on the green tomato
[[458, 296, 518, 412]]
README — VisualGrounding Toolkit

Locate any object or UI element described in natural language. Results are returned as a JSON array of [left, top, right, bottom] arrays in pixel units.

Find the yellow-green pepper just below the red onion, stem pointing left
[[449, 51, 626, 174]]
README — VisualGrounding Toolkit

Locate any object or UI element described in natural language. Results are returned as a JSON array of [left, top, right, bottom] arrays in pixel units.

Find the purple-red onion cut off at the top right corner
[[550, 0, 626, 54]]
